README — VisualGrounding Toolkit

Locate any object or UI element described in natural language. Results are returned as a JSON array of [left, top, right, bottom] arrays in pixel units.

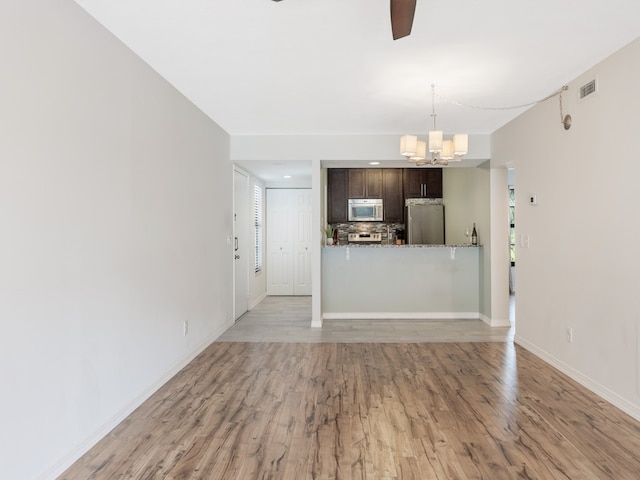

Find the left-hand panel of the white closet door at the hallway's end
[[267, 189, 293, 295]]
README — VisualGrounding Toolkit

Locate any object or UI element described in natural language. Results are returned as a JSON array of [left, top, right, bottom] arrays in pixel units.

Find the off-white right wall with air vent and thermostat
[[492, 41, 640, 419]]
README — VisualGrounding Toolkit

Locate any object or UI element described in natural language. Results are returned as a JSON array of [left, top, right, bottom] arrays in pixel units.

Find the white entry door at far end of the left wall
[[233, 170, 251, 320]]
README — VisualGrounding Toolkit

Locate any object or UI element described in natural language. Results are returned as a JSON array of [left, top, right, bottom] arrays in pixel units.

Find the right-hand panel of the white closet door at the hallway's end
[[290, 190, 311, 295]]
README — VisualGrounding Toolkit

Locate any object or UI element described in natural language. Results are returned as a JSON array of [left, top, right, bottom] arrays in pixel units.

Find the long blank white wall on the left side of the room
[[0, 0, 232, 479]]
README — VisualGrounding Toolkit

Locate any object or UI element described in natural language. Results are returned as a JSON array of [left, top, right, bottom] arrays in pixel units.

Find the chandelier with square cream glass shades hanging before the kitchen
[[400, 84, 469, 166]]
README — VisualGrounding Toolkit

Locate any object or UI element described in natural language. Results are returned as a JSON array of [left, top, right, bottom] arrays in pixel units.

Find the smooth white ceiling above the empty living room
[[76, 0, 640, 179]]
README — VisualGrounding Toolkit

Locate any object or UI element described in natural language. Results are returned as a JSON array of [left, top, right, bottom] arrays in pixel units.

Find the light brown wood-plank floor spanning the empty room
[[60, 299, 640, 480]]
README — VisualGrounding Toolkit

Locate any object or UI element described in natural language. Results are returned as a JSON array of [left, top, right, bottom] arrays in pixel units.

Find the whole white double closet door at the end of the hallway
[[267, 189, 311, 295]]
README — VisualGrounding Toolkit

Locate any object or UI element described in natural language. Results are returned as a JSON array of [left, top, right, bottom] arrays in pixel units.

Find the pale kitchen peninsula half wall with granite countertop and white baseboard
[[322, 244, 482, 319]]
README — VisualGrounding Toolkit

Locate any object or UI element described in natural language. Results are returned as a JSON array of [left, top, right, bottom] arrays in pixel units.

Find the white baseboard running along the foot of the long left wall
[[36, 321, 233, 480]]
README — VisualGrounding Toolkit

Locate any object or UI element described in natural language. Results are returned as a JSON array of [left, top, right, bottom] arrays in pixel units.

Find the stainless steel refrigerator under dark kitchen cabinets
[[407, 199, 444, 245]]
